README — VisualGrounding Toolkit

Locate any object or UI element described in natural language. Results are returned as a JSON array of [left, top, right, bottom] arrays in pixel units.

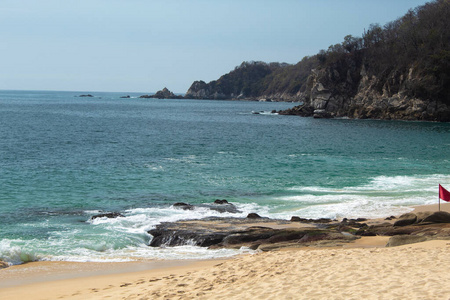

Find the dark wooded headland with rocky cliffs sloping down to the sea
[[186, 0, 450, 121]]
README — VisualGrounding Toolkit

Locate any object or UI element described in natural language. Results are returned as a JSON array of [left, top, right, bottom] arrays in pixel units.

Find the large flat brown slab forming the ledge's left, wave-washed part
[[149, 218, 357, 249]]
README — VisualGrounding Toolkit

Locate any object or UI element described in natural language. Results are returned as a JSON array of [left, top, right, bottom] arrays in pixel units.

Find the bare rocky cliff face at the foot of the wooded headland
[[280, 55, 450, 122]]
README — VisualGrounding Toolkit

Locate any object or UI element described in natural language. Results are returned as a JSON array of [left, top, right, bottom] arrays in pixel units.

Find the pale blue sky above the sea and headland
[[0, 0, 427, 93]]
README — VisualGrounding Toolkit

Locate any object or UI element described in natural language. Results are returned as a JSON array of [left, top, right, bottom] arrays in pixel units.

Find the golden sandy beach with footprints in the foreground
[[0, 204, 450, 299]]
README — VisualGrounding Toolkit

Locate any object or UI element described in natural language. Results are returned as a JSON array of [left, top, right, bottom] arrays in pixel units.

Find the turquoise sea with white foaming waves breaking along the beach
[[0, 91, 450, 263]]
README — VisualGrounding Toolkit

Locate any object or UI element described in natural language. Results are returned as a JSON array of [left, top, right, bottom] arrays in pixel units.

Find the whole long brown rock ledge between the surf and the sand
[[148, 212, 450, 251]]
